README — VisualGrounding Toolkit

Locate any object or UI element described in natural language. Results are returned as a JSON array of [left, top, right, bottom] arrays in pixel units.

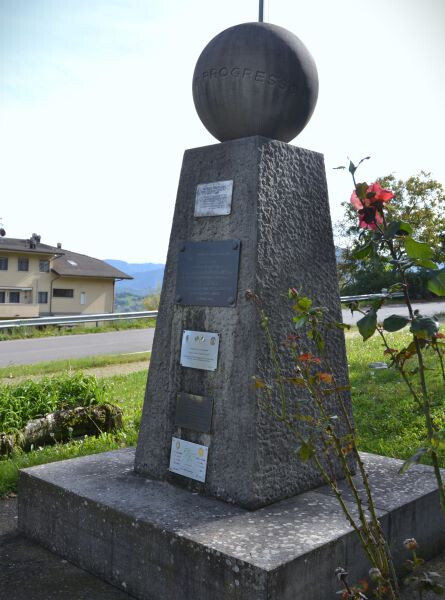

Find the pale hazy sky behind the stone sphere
[[0, 0, 445, 262]]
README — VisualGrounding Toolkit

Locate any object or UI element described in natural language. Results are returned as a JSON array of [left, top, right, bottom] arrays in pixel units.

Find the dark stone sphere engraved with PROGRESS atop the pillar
[[193, 23, 318, 142]]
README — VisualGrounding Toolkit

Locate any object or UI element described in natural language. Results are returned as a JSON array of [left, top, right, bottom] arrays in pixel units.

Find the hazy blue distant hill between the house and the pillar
[[104, 258, 165, 296]]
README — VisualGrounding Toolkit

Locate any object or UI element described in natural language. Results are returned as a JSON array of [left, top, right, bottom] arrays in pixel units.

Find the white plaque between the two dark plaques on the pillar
[[180, 330, 219, 371]]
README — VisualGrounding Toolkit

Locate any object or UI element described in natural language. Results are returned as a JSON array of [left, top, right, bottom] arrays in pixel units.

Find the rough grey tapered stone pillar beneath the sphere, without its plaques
[[135, 137, 349, 509]]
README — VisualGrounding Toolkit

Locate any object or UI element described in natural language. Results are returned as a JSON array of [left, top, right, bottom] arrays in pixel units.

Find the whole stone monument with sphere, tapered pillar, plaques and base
[[19, 15, 444, 600]]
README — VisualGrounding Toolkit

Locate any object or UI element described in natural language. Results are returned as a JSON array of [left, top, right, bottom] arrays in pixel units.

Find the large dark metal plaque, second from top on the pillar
[[176, 240, 241, 306]]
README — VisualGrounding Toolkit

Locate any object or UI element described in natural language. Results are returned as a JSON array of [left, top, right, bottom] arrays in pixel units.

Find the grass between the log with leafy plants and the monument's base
[[0, 371, 147, 497]]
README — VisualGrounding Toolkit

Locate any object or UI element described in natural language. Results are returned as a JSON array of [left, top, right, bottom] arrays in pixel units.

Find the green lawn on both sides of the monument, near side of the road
[[0, 329, 445, 496]]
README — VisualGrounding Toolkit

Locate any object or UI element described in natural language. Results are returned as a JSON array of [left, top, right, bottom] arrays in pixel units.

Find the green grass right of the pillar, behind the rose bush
[[347, 331, 445, 466]]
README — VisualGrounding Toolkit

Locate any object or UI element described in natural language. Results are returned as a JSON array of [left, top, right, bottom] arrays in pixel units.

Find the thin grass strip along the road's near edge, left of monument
[[0, 352, 150, 379]]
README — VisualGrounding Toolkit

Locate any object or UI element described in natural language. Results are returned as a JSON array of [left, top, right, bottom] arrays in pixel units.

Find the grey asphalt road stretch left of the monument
[[0, 329, 154, 367]]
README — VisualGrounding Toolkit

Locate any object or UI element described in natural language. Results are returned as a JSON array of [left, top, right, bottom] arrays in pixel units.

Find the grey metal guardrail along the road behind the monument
[[0, 292, 403, 329]]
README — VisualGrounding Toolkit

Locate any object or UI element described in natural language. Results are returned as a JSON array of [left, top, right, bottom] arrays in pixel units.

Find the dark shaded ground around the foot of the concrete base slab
[[0, 498, 445, 600]]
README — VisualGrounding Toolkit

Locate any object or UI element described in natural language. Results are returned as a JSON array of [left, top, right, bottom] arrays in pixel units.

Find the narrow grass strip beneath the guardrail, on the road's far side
[[0, 319, 156, 341]]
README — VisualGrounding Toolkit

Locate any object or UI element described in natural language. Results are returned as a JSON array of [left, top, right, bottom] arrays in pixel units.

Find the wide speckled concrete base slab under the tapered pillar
[[19, 449, 445, 600]]
